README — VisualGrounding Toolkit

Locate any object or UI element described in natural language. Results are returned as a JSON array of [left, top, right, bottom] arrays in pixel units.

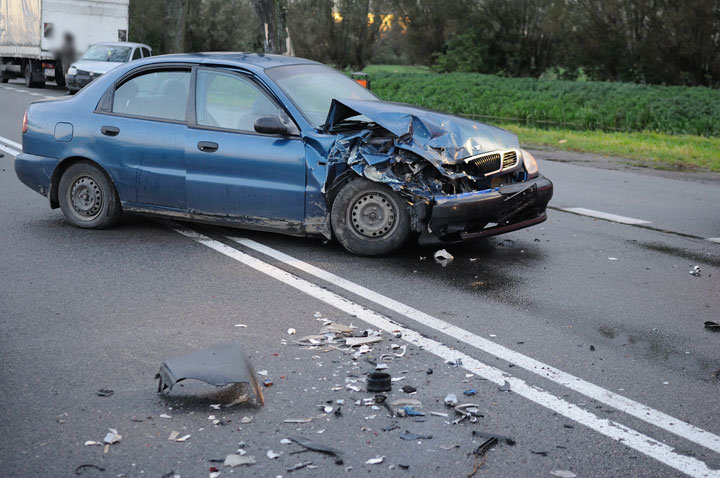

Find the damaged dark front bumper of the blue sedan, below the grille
[[419, 176, 553, 244]]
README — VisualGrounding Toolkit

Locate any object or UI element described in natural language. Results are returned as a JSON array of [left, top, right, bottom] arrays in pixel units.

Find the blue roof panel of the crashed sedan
[[142, 52, 321, 70]]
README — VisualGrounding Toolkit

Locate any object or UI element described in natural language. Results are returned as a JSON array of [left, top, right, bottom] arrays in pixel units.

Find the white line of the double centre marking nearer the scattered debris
[[174, 227, 720, 477]]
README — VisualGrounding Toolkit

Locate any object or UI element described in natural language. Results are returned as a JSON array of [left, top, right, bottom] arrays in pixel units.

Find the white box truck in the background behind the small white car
[[0, 0, 130, 88]]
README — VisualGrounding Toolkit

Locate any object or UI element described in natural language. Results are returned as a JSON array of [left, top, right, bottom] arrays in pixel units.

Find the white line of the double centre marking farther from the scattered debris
[[228, 237, 720, 453]]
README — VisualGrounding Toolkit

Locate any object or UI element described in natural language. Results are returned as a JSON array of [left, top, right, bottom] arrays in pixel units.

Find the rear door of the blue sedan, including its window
[[96, 66, 191, 211]]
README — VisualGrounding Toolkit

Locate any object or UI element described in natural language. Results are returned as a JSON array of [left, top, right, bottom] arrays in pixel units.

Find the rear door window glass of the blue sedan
[[112, 70, 190, 121]]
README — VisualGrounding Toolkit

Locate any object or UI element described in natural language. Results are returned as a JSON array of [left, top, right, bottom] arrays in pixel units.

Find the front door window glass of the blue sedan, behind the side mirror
[[195, 70, 281, 131]]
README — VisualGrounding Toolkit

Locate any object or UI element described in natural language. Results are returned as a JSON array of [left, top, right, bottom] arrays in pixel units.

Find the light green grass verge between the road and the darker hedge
[[499, 124, 720, 172]]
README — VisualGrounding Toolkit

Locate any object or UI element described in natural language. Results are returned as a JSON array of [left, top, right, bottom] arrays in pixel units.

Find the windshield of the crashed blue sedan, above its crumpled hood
[[265, 65, 378, 128]]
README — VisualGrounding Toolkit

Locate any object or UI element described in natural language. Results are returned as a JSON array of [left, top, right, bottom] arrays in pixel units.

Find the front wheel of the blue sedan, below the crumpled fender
[[330, 178, 410, 256]]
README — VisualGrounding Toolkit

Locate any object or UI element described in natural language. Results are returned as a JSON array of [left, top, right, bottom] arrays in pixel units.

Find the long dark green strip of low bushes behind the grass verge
[[372, 73, 720, 136]]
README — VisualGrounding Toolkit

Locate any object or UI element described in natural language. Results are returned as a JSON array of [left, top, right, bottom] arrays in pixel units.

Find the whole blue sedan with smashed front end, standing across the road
[[15, 53, 552, 255]]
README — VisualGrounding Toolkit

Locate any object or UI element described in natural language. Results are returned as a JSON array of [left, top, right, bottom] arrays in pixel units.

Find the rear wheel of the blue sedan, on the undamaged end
[[58, 161, 122, 229]]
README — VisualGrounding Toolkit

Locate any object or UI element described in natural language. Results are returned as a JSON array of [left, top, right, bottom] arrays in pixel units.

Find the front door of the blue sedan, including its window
[[185, 68, 305, 222]]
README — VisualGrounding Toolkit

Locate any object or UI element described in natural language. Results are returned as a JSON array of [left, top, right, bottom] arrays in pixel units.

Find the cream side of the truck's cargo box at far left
[[0, 0, 42, 49]]
